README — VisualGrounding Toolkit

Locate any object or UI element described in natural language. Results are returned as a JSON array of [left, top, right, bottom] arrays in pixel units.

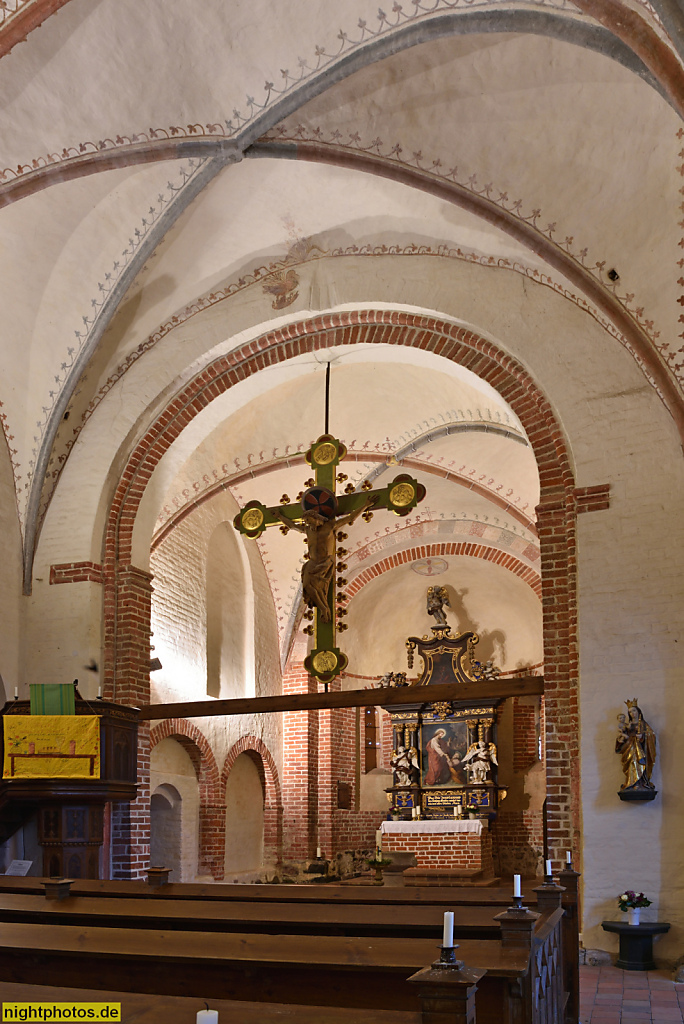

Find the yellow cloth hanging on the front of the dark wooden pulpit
[[2, 715, 100, 778]]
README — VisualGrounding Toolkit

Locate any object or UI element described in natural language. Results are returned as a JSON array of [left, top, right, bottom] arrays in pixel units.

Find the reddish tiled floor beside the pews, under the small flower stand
[[580, 967, 684, 1024]]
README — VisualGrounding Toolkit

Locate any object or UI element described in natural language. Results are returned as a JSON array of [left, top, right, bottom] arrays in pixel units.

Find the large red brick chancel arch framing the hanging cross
[[103, 309, 580, 872]]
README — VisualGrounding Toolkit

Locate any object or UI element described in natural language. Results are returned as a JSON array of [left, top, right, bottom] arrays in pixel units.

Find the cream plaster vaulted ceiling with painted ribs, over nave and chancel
[[0, 0, 684, 657]]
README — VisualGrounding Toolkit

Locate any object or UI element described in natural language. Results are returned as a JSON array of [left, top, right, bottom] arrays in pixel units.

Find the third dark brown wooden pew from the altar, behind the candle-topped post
[[0, 924, 529, 1024]]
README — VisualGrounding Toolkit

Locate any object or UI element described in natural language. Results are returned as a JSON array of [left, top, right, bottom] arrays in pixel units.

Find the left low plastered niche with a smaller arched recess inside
[[149, 736, 200, 882]]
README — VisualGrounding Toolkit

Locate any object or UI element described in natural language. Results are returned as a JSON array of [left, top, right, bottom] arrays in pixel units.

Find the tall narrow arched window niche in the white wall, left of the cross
[[206, 522, 254, 698]]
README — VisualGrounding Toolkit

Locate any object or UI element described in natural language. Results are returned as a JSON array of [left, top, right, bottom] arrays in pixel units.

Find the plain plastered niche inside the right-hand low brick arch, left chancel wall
[[225, 751, 264, 882]]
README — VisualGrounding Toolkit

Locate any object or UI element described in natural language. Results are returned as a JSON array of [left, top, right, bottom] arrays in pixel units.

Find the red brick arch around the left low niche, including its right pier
[[149, 718, 225, 882]]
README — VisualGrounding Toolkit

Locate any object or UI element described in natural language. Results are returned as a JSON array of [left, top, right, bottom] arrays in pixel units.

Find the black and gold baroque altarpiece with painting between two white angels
[[387, 624, 506, 820]]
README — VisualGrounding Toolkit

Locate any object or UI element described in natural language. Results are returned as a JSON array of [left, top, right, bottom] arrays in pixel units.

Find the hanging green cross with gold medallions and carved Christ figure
[[233, 434, 425, 683]]
